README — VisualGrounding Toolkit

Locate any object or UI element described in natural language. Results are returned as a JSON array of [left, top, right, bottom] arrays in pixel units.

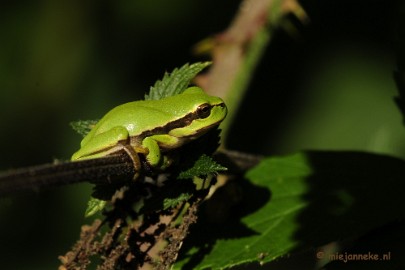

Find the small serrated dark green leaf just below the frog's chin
[[177, 154, 226, 179]]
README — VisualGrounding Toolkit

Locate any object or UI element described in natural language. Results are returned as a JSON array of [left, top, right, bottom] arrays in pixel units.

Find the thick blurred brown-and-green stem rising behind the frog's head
[[196, 0, 306, 143]]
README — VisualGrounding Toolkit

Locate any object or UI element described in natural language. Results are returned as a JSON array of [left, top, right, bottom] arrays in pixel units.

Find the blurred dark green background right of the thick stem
[[228, 1, 405, 157]]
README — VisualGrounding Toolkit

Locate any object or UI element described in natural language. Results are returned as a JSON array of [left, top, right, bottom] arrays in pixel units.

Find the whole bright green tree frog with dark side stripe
[[72, 87, 227, 175]]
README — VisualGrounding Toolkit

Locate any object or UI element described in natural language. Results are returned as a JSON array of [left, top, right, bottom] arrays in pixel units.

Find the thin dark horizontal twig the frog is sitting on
[[0, 150, 261, 196]]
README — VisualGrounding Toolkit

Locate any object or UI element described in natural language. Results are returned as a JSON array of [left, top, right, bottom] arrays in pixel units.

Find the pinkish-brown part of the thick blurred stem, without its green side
[[196, 0, 307, 98]]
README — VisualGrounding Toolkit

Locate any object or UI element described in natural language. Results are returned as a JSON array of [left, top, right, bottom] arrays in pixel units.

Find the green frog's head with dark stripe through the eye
[[169, 87, 227, 139]]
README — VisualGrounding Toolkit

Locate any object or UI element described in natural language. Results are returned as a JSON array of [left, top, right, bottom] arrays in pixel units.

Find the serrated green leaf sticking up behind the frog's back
[[145, 62, 211, 100]]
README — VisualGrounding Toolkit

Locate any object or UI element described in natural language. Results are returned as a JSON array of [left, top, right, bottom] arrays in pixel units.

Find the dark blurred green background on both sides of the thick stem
[[0, 0, 405, 269]]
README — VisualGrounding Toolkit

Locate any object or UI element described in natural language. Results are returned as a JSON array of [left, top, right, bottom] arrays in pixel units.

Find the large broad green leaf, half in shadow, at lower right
[[176, 152, 405, 269]]
